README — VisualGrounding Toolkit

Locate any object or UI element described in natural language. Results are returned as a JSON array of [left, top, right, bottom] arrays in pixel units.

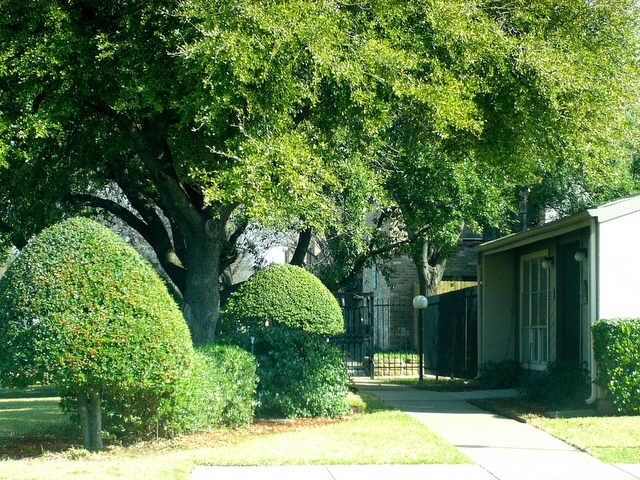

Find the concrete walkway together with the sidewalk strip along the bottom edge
[[193, 378, 640, 480]]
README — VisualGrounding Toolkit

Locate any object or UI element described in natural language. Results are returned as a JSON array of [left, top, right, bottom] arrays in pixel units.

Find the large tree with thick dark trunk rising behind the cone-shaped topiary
[[0, 0, 380, 342]]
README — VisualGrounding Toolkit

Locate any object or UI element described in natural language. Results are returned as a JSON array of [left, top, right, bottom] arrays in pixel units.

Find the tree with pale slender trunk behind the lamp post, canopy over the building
[[312, 0, 640, 293]]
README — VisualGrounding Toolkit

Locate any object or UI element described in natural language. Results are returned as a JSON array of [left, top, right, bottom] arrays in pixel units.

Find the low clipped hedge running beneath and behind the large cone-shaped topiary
[[61, 345, 258, 442]]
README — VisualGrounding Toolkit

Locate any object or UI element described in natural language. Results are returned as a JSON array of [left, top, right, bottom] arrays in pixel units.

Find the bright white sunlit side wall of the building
[[598, 212, 640, 319]]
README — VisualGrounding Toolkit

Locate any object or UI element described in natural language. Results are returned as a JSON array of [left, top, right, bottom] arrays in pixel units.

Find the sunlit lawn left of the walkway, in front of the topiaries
[[0, 395, 470, 479]]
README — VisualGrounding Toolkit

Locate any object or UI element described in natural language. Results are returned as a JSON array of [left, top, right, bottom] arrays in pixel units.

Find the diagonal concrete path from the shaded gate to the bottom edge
[[357, 379, 640, 480]]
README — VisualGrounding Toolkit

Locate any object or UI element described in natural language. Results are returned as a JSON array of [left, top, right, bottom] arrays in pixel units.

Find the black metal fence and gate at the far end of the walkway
[[334, 288, 477, 377]]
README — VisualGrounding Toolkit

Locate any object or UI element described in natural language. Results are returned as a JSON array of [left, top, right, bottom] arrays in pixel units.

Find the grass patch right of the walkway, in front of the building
[[472, 400, 640, 463]]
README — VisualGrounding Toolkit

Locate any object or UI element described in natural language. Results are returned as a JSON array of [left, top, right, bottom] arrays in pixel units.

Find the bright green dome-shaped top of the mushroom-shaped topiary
[[222, 265, 344, 335]]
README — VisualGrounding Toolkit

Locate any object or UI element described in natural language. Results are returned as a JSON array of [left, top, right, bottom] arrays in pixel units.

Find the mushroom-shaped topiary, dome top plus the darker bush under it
[[221, 265, 348, 417]]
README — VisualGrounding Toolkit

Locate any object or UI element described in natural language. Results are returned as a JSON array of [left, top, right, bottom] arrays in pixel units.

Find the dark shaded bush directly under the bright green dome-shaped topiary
[[230, 326, 349, 417]]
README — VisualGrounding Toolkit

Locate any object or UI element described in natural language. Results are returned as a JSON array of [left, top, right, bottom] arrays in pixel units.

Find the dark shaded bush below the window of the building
[[520, 363, 589, 407]]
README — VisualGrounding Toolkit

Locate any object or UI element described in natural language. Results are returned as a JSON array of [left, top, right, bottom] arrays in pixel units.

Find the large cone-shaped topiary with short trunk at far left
[[0, 218, 193, 449]]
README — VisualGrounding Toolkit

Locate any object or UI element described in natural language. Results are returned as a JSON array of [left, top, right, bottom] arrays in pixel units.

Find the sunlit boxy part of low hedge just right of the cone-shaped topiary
[[161, 345, 258, 436]]
